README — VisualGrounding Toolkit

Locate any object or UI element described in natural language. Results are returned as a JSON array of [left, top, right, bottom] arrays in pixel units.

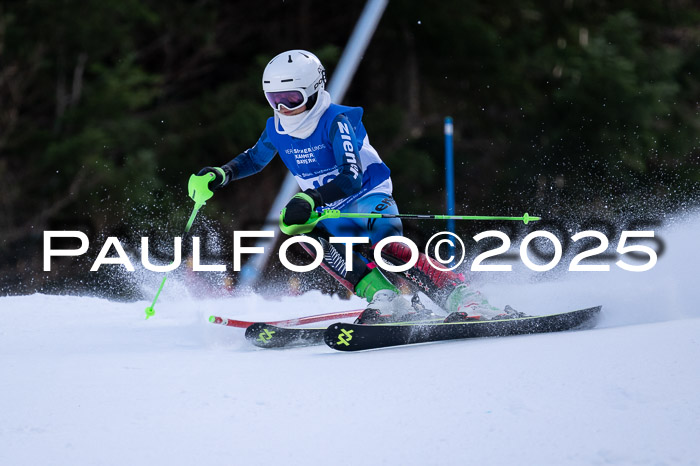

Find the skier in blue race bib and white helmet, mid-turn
[[198, 50, 516, 323]]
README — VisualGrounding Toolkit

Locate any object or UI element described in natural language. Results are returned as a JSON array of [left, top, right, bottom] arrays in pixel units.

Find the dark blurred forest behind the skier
[[0, 0, 700, 299]]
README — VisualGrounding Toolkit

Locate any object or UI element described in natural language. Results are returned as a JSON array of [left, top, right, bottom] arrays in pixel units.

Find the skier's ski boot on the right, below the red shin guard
[[444, 284, 526, 323]]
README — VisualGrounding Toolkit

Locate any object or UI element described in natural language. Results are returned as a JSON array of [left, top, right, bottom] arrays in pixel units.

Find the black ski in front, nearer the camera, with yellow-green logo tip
[[324, 306, 601, 351]]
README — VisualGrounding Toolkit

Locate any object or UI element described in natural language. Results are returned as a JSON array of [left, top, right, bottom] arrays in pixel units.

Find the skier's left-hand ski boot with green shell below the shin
[[355, 269, 433, 324]]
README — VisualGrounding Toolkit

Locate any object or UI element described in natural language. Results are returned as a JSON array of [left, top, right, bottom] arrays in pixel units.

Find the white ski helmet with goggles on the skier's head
[[263, 50, 326, 110]]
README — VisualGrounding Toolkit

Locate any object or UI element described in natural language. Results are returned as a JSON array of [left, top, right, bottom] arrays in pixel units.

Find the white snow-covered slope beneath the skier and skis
[[0, 216, 700, 465]]
